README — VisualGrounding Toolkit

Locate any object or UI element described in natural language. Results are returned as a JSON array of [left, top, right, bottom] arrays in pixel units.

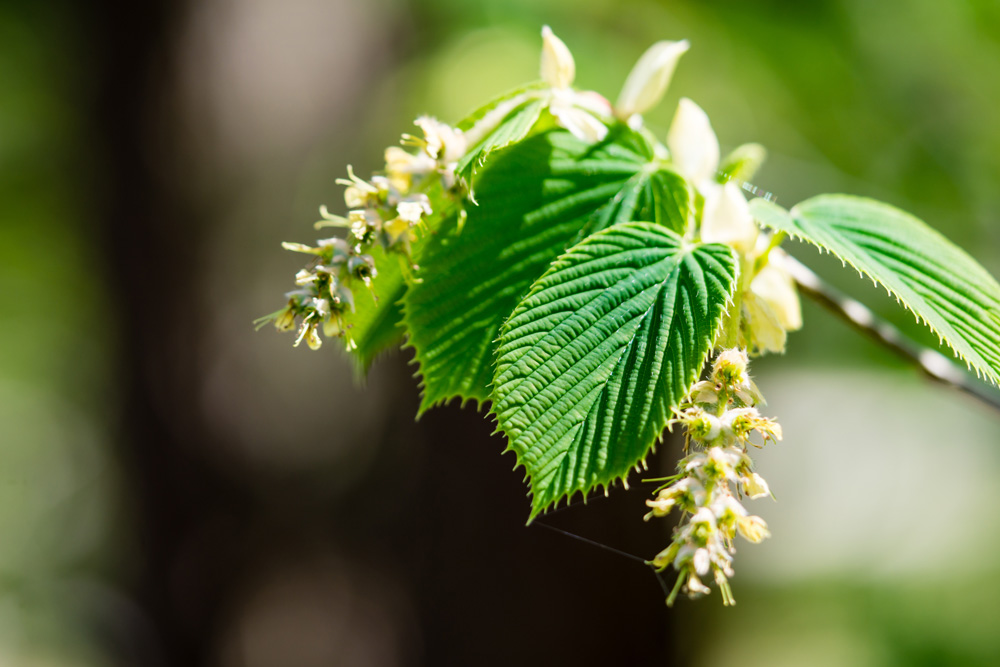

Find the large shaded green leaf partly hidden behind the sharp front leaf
[[403, 126, 690, 411]]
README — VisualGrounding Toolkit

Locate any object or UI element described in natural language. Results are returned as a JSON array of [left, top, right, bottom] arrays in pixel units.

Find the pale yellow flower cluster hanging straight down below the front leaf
[[645, 349, 781, 605]]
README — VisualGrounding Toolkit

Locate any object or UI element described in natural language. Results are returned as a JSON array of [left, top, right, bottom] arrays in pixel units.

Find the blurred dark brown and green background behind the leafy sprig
[[0, 0, 1000, 667]]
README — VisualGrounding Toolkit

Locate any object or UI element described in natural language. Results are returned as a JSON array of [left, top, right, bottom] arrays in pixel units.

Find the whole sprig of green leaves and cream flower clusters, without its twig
[[265, 28, 1000, 544]]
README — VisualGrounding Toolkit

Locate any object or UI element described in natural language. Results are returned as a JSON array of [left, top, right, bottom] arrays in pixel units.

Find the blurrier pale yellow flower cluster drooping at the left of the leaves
[[259, 116, 465, 350]]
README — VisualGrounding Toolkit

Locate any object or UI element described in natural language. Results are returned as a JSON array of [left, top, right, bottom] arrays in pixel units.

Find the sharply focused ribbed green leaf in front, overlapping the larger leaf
[[493, 223, 737, 518]]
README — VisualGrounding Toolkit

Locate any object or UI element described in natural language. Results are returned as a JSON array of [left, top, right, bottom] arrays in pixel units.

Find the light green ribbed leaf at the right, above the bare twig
[[750, 195, 1000, 384]]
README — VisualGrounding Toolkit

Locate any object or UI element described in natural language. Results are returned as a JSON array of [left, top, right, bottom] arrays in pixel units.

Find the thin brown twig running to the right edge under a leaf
[[784, 256, 1000, 412]]
